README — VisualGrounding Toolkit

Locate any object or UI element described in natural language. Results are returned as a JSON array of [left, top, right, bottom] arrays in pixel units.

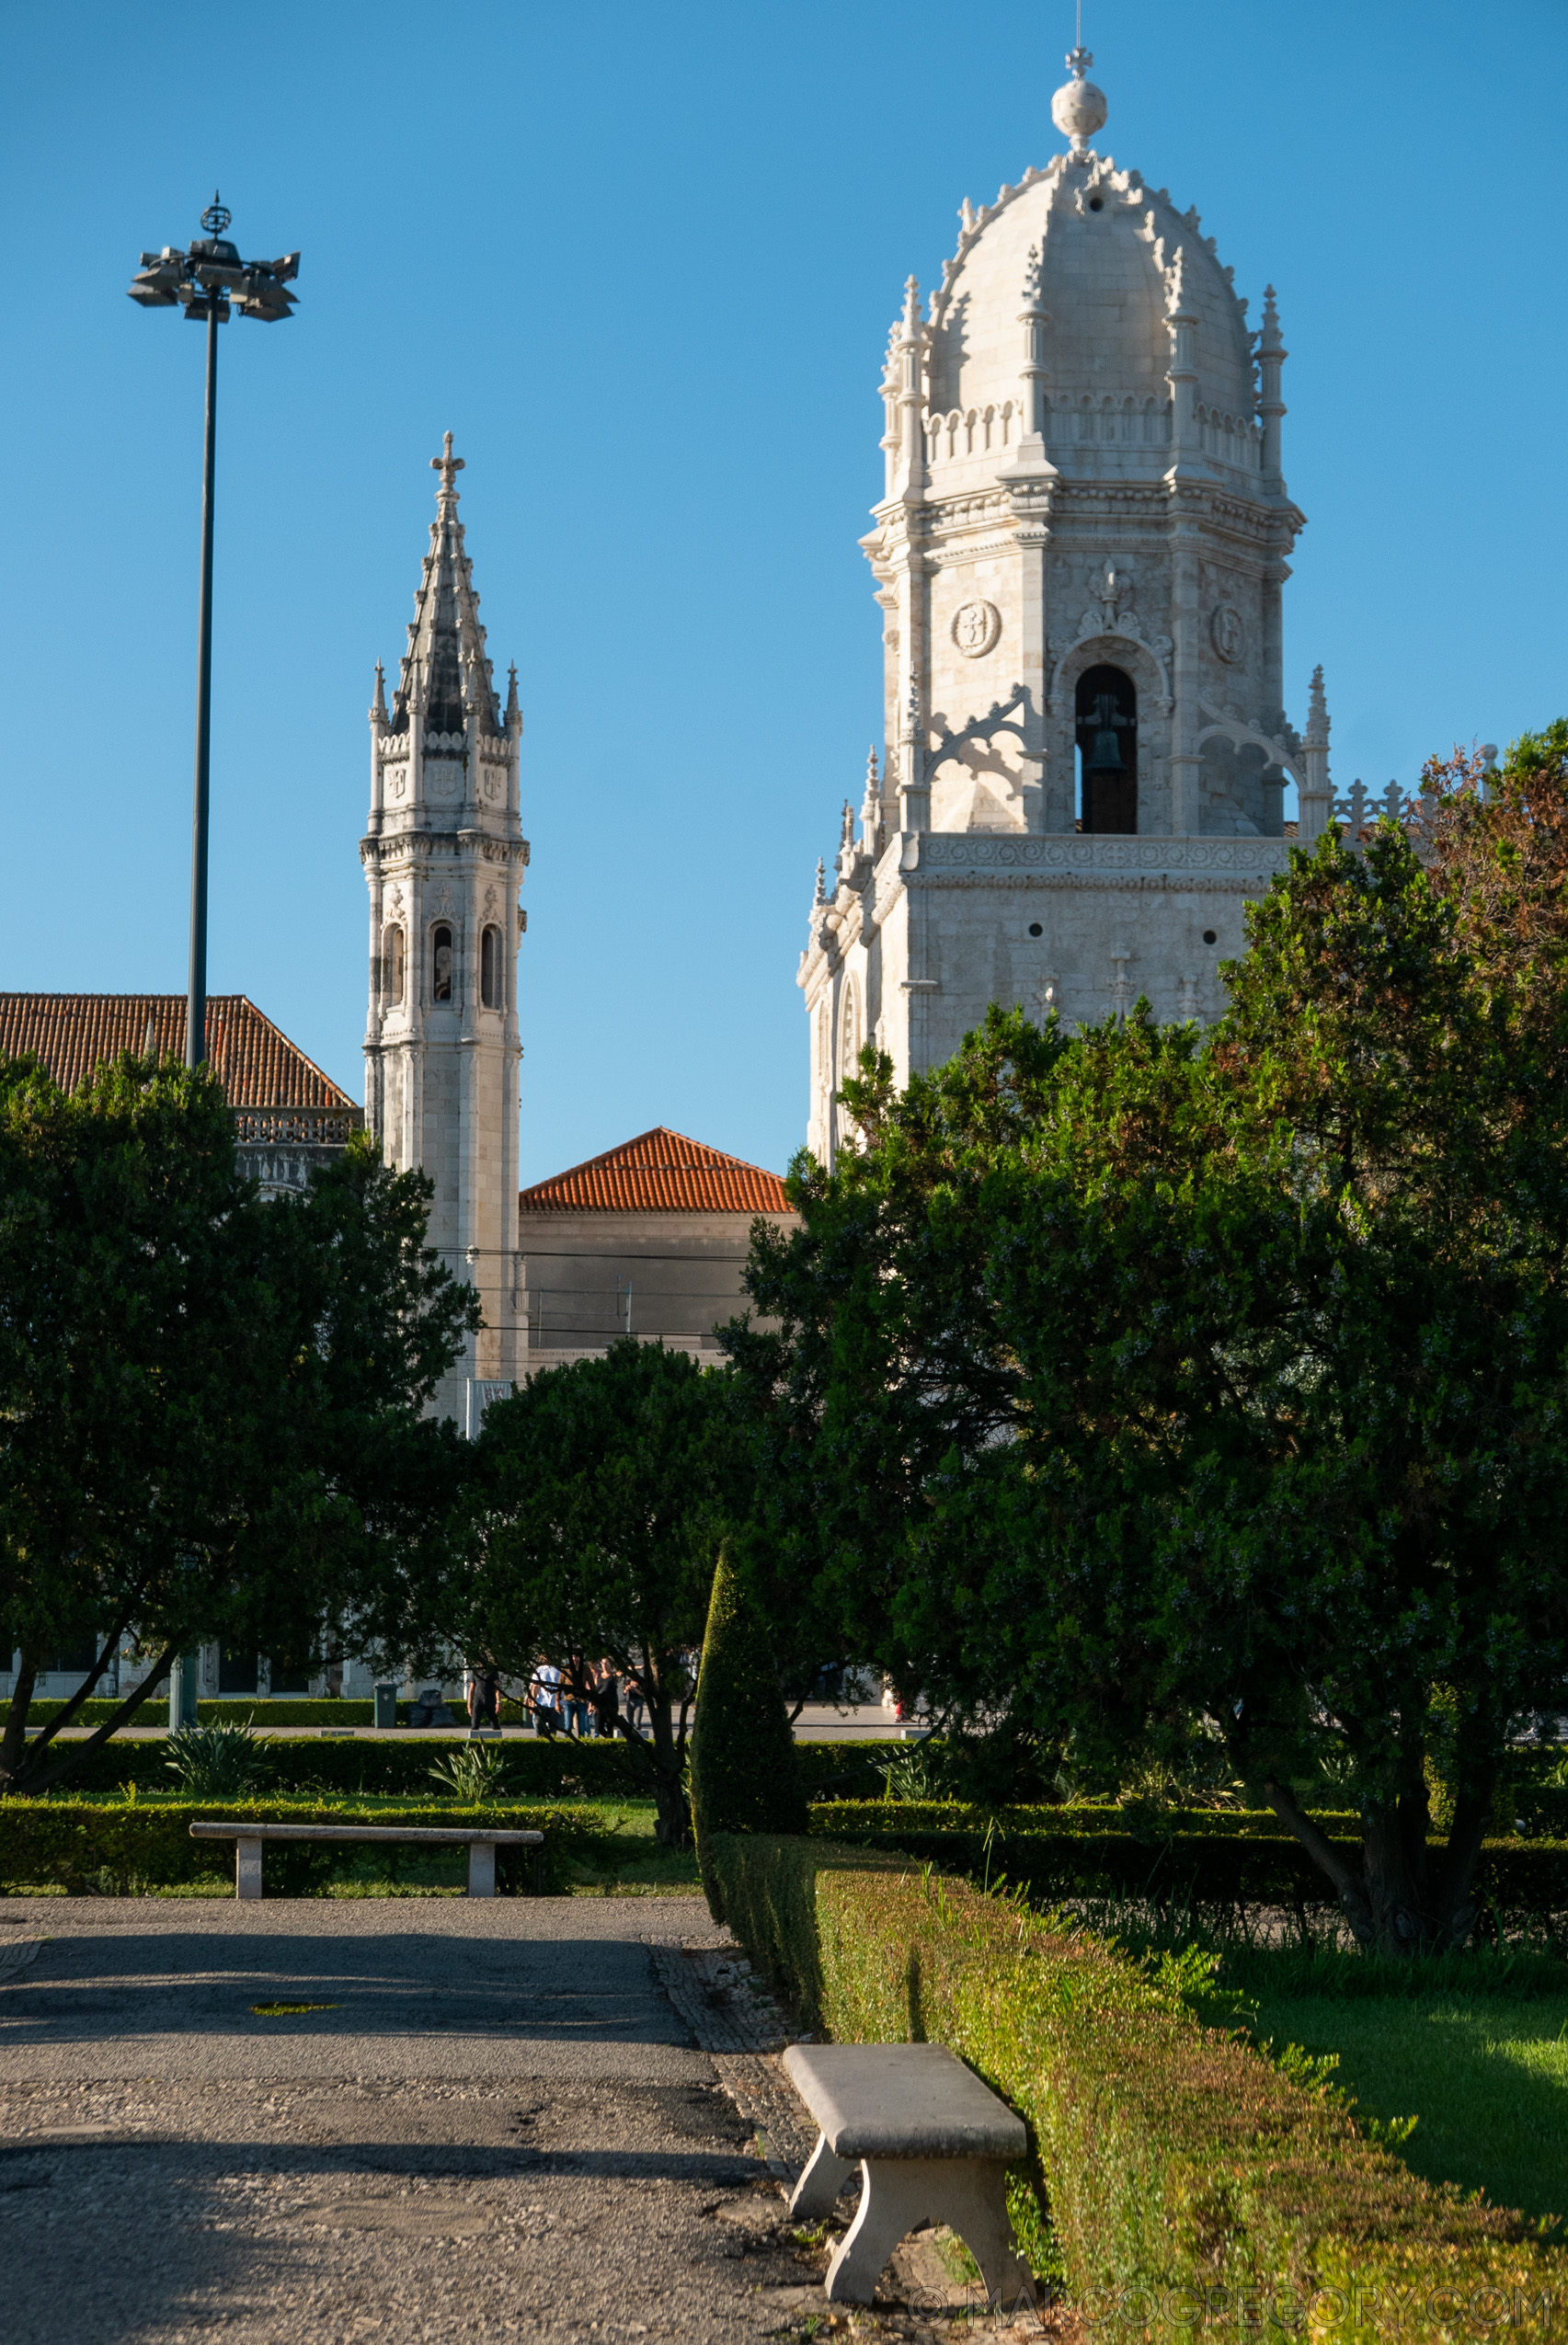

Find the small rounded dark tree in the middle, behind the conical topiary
[[464, 1342, 752, 1847]]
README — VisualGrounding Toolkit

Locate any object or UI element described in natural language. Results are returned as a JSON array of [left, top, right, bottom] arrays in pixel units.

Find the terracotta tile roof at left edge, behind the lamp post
[[0, 994, 354, 1109]]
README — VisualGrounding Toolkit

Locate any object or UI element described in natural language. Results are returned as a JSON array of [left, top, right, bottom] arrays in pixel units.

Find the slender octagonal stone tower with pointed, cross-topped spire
[[359, 431, 527, 1431]]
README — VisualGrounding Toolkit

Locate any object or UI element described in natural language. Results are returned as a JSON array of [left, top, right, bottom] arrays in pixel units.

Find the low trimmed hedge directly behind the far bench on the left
[[0, 1799, 604, 1897]]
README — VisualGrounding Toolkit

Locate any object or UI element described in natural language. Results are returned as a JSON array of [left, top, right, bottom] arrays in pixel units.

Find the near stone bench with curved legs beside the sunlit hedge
[[785, 2045, 1029, 2307]]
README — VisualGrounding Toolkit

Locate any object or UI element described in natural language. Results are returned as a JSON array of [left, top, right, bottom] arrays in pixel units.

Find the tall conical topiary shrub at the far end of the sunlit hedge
[[692, 1548, 807, 1920]]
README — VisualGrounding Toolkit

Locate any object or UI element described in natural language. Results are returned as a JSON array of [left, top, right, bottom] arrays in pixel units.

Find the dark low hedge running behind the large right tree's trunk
[[808, 1801, 1568, 1918]]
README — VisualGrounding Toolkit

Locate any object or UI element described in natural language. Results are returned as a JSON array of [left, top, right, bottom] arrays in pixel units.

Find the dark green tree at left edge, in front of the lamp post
[[0, 1056, 474, 1794]]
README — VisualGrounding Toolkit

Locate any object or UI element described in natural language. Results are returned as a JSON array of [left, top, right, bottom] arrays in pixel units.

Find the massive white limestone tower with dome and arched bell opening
[[799, 50, 1333, 1163]]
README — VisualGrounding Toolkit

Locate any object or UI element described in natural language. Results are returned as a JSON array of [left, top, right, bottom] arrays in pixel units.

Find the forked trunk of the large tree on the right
[[1259, 1770, 1495, 1958]]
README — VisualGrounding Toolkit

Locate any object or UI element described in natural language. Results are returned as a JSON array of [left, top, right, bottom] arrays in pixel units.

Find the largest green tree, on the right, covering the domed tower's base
[[738, 734, 1568, 1951]]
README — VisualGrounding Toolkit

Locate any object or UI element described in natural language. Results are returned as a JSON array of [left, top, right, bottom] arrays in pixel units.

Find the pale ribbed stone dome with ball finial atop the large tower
[[926, 50, 1261, 487]]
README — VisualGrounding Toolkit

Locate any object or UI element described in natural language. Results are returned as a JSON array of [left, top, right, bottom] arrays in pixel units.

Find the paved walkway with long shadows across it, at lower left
[[0, 1897, 1071, 2345]]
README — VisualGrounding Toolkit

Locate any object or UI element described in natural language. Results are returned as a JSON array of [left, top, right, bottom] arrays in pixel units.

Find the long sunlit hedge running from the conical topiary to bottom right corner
[[713, 1836, 1568, 2345]]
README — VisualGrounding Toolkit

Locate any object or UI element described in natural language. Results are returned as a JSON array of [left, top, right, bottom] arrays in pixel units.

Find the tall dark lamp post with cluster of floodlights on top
[[127, 195, 300, 1067]]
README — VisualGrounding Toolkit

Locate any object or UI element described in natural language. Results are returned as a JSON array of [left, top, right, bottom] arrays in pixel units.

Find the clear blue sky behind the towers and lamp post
[[0, 0, 1568, 1180]]
